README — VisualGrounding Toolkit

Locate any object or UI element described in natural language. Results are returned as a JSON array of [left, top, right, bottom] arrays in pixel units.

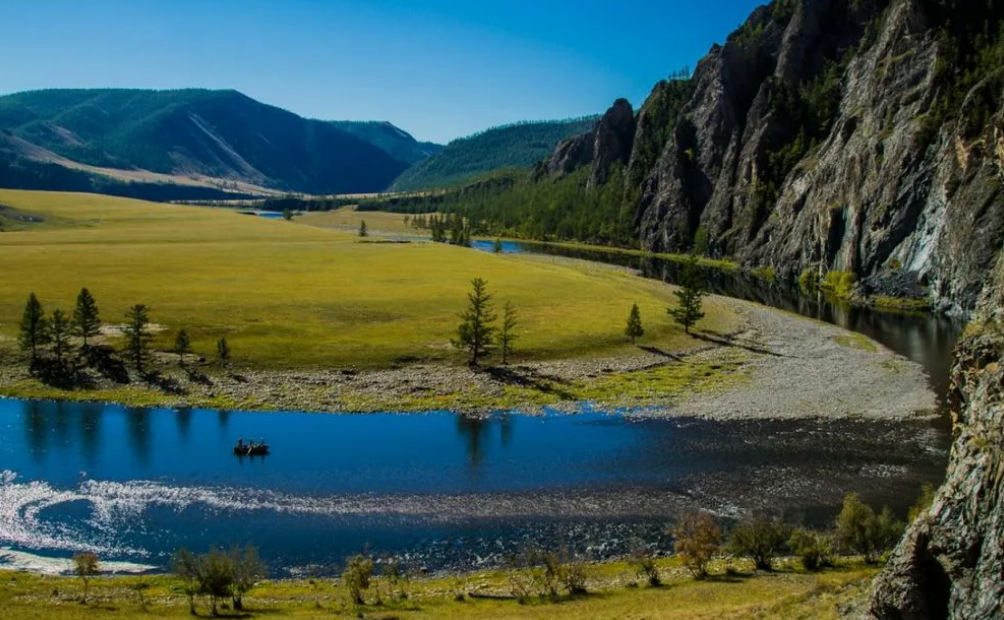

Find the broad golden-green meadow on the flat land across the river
[[0, 190, 738, 368]]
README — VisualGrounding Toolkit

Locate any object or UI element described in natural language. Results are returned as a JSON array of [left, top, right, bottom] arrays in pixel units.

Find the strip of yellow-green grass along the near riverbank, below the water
[[0, 560, 876, 620]]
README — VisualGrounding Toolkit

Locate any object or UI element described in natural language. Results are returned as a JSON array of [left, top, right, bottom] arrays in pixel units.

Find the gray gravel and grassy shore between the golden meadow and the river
[[0, 296, 937, 419]]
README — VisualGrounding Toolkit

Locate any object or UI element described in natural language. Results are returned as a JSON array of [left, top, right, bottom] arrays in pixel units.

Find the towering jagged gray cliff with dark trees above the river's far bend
[[548, 0, 1004, 312]]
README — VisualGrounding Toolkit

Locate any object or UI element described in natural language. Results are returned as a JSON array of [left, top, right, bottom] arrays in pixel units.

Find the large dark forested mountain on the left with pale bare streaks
[[0, 89, 408, 194]]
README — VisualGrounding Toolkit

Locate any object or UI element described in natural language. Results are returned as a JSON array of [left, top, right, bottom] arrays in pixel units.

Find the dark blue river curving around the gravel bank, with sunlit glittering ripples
[[0, 238, 958, 575]]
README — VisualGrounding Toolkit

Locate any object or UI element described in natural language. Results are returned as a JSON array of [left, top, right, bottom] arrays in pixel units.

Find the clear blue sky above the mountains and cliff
[[0, 0, 762, 141]]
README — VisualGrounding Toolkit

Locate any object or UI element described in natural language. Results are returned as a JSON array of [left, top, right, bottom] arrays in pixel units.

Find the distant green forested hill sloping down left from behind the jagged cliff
[[391, 117, 595, 192]]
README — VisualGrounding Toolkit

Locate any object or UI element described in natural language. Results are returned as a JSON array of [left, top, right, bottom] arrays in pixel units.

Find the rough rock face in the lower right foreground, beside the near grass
[[865, 314, 1004, 620]]
